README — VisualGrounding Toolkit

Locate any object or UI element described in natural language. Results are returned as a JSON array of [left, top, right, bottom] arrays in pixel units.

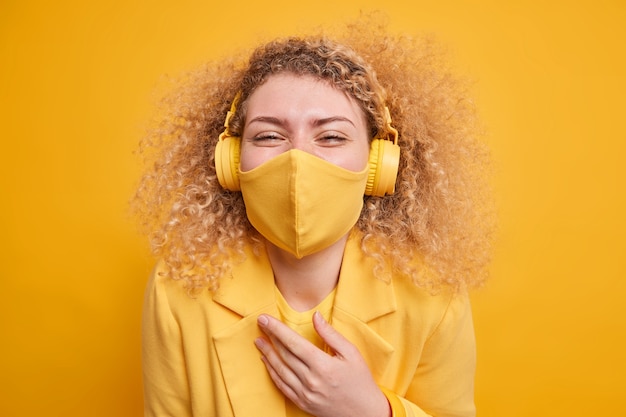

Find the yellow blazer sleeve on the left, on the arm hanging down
[[142, 269, 192, 417]]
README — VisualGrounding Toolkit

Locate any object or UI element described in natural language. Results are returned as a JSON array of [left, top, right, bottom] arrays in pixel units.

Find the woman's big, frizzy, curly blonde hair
[[133, 21, 494, 292]]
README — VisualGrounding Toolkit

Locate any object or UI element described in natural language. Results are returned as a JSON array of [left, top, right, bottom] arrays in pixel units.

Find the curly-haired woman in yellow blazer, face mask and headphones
[[137, 21, 491, 417]]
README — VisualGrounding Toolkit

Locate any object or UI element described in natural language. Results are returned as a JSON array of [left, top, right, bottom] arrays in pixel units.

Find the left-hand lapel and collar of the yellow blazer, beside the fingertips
[[213, 247, 285, 417]]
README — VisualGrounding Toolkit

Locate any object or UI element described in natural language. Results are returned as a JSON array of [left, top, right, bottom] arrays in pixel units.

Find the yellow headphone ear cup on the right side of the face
[[365, 139, 400, 197]]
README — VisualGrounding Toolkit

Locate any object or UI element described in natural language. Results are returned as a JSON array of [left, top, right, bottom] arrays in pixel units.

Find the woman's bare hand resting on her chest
[[255, 312, 391, 417]]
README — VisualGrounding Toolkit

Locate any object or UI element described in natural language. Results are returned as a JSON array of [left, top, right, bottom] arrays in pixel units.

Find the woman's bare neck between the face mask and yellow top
[[266, 234, 348, 311]]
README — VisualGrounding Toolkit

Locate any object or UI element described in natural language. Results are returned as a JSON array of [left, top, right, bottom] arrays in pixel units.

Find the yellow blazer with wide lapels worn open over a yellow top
[[143, 238, 475, 417]]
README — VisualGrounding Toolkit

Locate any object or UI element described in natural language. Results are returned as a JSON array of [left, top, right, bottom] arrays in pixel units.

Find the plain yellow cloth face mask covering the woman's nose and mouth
[[239, 149, 368, 259]]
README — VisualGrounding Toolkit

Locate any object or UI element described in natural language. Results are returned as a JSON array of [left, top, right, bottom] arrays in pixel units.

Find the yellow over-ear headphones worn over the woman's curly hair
[[215, 92, 400, 197]]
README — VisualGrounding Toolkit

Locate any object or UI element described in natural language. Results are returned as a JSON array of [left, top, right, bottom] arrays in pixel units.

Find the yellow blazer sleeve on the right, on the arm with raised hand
[[383, 294, 476, 417]]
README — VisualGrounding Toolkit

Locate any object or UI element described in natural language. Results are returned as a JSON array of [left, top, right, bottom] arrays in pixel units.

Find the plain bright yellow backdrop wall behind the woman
[[0, 0, 626, 417]]
